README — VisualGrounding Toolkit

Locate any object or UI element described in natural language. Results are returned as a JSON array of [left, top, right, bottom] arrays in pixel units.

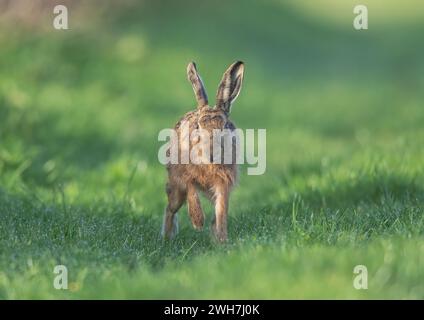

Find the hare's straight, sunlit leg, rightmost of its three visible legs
[[212, 186, 230, 242]]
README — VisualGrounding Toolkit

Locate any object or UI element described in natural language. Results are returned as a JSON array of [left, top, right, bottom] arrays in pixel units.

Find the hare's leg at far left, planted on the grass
[[162, 183, 186, 239]]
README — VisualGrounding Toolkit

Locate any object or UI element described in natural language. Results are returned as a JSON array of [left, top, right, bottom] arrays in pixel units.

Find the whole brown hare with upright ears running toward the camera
[[162, 61, 244, 242]]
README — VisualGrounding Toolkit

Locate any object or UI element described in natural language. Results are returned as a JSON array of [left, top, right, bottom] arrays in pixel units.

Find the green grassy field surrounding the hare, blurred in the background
[[0, 0, 424, 299]]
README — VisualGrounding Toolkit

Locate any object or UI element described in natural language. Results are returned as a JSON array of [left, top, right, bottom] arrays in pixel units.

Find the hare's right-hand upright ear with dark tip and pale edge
[[216, 61, 244, 113]]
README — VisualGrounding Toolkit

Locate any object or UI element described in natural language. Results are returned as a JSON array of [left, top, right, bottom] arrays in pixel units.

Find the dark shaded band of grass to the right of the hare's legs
[[229, 166, 424, 244]]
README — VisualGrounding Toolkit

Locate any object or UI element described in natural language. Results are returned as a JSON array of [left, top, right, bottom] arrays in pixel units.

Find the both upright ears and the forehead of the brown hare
[[187, 61, 244, 130]]
